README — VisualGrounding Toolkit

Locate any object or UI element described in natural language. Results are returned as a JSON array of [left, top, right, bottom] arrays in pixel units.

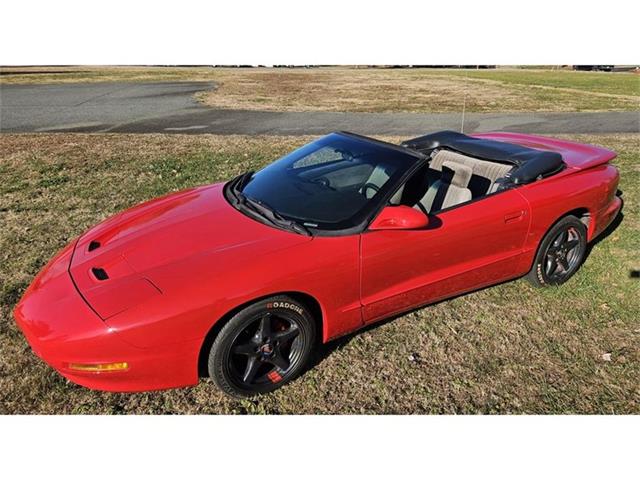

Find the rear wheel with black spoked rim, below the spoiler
[[526, 215, 587, 287]]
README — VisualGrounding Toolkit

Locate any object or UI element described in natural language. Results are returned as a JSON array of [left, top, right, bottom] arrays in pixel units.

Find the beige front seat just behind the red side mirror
[[416, 162, 472, 213]]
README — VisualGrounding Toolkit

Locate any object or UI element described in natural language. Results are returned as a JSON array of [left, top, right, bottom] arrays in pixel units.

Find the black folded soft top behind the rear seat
[[401, 130, 565, 183]]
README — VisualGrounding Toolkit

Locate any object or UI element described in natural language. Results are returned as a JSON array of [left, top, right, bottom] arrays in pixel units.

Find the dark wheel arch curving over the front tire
[[198, 291, 325, 377]]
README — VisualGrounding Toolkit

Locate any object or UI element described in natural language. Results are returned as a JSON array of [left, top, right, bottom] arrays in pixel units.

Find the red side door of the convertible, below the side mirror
[[360, 189, 531, 323]]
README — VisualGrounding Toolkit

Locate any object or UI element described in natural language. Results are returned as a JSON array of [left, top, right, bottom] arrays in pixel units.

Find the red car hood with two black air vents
[[69, 184, 311, 319]]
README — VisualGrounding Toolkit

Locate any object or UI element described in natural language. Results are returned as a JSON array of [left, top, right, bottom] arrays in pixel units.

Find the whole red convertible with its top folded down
[[15, 131, 622, 396]]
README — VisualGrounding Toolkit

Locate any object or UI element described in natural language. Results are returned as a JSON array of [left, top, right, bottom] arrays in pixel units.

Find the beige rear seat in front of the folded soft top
[[429, 150, 513, 198]]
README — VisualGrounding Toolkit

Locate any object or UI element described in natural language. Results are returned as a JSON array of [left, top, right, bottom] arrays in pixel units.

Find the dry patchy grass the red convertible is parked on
[[0, 133, 640, 414]]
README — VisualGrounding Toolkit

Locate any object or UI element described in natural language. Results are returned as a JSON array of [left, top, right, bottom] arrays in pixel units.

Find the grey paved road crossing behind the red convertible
[[0, 82, 640, 135]]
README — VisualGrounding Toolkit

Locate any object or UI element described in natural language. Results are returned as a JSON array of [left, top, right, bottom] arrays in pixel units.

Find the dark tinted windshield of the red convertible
[[228, 133, 416, 230]]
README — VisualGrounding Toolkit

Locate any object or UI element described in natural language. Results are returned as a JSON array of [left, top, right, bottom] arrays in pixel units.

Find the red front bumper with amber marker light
[[14, 244, 200, 392]]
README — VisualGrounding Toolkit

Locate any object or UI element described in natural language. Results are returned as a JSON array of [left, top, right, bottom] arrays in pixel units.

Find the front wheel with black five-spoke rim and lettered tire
[[208, 295, 316, 397]]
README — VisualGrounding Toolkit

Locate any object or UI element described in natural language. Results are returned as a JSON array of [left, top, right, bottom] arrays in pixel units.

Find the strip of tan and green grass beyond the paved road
[[0, 67, 640, 113]]
